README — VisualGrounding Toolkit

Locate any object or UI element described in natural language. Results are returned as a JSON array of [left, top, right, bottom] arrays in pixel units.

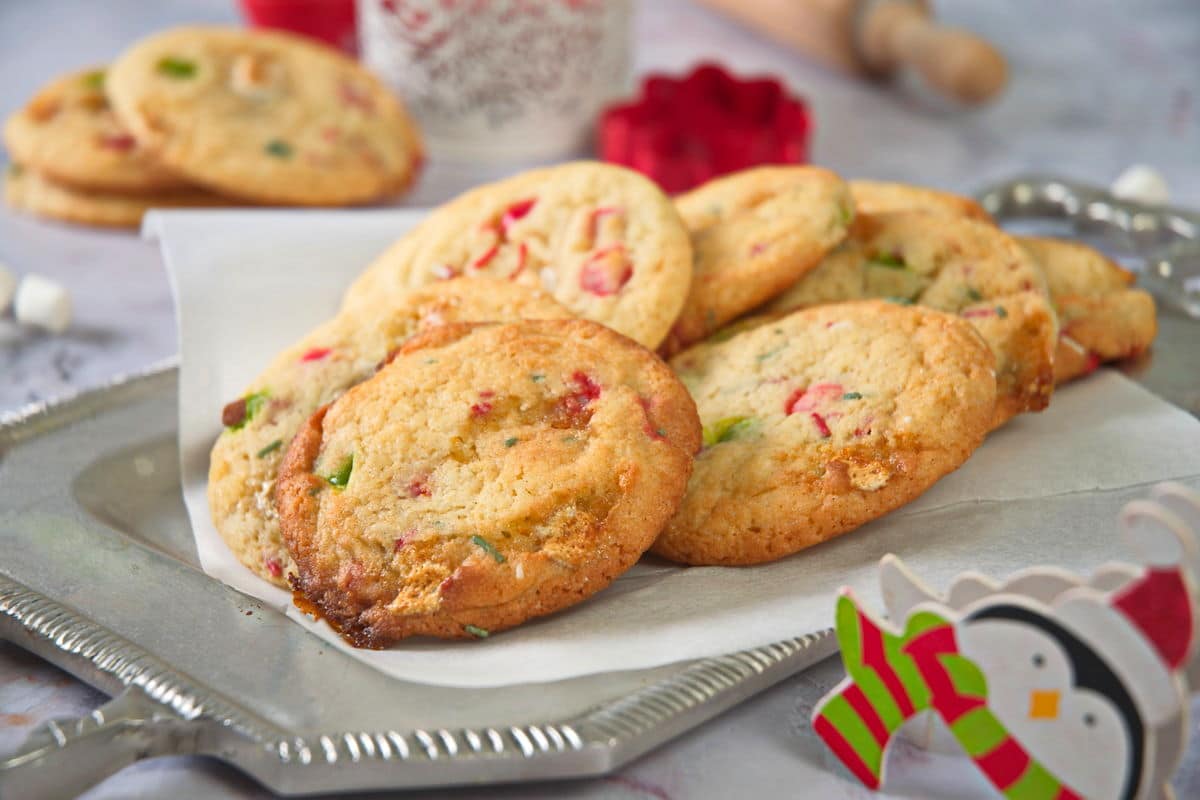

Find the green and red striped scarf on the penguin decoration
[[812, 593, 1081, 800]]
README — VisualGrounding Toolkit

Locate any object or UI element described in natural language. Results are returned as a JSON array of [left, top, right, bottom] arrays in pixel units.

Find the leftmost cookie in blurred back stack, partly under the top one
[[4, 68, 187, 192]]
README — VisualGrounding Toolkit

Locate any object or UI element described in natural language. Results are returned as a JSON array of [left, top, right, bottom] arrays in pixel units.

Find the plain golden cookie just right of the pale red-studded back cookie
[[665, 167, 854, 354]]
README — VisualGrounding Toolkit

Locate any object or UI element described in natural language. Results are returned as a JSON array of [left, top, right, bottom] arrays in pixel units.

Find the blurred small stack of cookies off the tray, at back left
[[4, 28, 421, 227]]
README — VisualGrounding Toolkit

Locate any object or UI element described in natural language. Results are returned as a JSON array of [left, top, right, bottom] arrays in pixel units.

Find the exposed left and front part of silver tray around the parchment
[[0, 367, 835, 798]]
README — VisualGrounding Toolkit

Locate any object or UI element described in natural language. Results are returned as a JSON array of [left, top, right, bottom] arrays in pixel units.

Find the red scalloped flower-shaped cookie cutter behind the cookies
[[600, 64, 811, 192]]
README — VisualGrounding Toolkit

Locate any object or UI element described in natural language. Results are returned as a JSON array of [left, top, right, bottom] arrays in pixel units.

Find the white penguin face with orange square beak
[[958, 618, 1133, 800]]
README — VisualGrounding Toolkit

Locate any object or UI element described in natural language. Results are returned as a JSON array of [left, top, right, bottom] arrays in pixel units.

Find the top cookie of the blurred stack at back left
[[107, 26, 421, 205]]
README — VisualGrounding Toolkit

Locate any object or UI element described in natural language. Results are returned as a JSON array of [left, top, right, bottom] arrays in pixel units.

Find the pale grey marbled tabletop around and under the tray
[[0, 0, 1200, 799]]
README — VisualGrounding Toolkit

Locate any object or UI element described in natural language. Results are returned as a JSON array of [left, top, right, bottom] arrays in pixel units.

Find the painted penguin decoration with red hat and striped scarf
[[812, 483, 1200, 800]]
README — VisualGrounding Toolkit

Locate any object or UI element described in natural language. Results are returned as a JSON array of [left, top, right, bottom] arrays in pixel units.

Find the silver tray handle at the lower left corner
[[0, 686, 200, 800]]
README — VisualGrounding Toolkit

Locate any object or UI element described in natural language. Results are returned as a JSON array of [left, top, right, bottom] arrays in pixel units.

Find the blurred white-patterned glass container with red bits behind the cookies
[[359, 0, 634, 162]]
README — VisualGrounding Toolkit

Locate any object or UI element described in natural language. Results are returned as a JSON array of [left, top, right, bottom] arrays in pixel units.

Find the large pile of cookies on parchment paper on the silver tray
[[209, 163, 1154, 646]]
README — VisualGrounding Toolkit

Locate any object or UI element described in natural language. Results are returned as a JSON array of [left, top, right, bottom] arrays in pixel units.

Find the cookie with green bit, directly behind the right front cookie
[[768, 211, 1057, 426]]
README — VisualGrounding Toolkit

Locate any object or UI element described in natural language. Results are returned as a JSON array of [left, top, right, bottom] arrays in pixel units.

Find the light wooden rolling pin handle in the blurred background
[[858, 0, 1008, 104]]
